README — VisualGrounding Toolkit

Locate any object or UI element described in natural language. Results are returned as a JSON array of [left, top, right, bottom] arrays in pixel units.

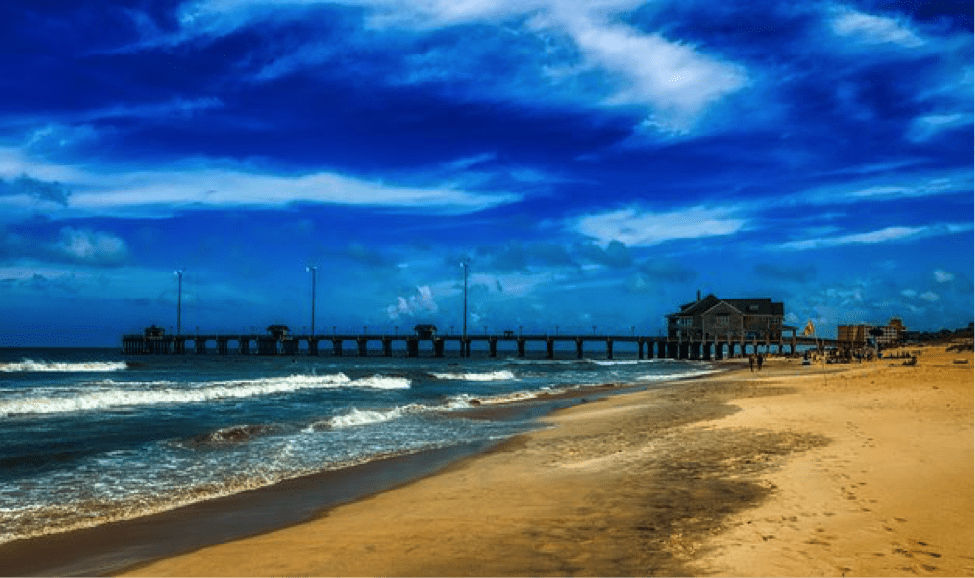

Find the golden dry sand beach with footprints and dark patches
[[118, 348, 975, 576]]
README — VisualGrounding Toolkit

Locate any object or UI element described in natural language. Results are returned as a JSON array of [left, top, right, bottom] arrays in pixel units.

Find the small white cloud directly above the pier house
[[567, 207, 746, 247]]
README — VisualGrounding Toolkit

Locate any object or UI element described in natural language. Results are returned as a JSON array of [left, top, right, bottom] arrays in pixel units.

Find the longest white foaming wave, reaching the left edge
[[0, 373, 410, 416]]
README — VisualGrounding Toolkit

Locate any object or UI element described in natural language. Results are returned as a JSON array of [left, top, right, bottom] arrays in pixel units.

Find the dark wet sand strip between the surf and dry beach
[[0, 376, 688, 576]]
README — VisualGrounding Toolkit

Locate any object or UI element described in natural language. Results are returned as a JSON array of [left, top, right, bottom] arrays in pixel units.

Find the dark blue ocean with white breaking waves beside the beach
[[0, 349, 713, 544]]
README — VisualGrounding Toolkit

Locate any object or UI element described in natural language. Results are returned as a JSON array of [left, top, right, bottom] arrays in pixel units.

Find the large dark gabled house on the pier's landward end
[[667, 293, 794, 342]]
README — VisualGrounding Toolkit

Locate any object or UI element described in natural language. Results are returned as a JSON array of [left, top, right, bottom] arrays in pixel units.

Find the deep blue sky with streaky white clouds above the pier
[[0, 0, 975, 346]]
